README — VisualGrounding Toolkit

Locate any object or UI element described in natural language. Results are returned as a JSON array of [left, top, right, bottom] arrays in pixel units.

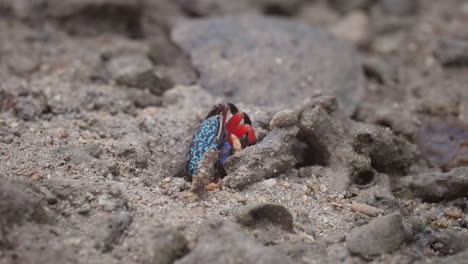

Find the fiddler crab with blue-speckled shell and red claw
[[185, 103, 257, 189]]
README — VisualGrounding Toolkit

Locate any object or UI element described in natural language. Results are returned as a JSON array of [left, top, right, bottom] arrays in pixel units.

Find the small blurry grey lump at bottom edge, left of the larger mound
[[143, 227, 189, 264]]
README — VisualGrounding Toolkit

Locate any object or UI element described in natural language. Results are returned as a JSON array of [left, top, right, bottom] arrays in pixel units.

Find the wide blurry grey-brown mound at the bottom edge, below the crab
[[175, 220, 292, 264]]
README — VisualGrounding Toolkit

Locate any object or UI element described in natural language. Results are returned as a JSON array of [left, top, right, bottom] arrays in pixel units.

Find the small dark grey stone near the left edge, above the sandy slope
[[14, 92, 49, 121]]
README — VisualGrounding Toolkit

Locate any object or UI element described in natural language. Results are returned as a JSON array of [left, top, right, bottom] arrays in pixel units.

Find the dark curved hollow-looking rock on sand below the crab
[[236, 203, 294, 232]]
